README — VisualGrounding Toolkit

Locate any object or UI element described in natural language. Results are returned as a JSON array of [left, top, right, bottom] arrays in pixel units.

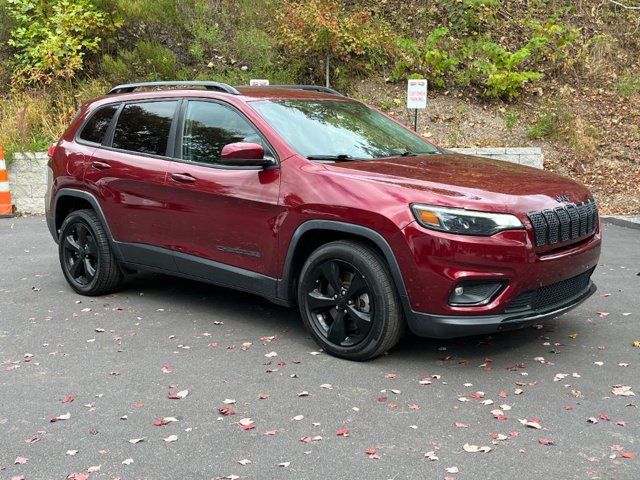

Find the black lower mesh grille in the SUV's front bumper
[[505, 267, 595, 313]]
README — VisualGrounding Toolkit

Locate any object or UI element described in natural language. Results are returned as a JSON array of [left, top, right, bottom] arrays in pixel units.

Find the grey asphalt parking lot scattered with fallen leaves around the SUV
[[0, 217, 640, 480]]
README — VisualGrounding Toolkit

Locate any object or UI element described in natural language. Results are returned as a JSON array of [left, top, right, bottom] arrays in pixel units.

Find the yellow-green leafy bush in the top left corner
[[5, 0, 115, 86]]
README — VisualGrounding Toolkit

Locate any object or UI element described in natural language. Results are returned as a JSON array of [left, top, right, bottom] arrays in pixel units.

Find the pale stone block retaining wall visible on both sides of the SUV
[[8, 147, 544, 214]]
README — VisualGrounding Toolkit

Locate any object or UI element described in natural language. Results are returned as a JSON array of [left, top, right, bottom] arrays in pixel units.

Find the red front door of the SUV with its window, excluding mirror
[[167, 100, 282, 277]]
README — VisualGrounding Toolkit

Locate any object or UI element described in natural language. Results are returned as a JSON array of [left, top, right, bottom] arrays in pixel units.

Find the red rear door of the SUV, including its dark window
[[85, 99, 180, 246]]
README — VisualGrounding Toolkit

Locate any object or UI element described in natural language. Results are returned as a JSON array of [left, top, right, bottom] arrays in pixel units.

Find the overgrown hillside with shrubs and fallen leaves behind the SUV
[[0, 0, 640, 213]]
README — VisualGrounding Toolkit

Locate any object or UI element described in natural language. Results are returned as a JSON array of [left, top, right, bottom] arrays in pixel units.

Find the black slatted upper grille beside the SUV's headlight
[[527, 199, 598, 247]]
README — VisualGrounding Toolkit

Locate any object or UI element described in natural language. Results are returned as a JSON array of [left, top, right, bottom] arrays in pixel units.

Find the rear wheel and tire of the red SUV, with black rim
[[58, 210, 124, 296]]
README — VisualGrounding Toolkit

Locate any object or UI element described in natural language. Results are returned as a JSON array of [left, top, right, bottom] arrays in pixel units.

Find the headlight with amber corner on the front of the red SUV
[[411, 205, 524, 236]]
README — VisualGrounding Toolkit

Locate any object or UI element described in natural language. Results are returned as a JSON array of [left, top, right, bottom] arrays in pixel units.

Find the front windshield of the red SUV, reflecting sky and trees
[[251, 100, 438, 160]]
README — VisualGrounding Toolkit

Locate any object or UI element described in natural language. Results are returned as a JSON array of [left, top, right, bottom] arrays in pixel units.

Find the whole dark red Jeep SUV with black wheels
[[47, 82, 600, 360]]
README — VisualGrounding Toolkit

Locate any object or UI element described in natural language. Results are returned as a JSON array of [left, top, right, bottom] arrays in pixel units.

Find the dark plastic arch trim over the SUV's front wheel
[[277, 220, 411, 313]]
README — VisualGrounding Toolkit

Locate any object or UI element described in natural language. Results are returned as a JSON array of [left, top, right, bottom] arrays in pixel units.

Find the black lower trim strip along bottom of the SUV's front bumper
[[408, 282, 596, 339]]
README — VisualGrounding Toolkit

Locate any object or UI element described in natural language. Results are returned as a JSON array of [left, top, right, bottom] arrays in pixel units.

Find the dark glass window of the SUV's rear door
[[111, 101, 178, 155]]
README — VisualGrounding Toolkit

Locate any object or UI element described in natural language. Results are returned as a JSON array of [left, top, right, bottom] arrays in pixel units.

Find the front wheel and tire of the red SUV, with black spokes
[[298, 240, 404, 361]]
